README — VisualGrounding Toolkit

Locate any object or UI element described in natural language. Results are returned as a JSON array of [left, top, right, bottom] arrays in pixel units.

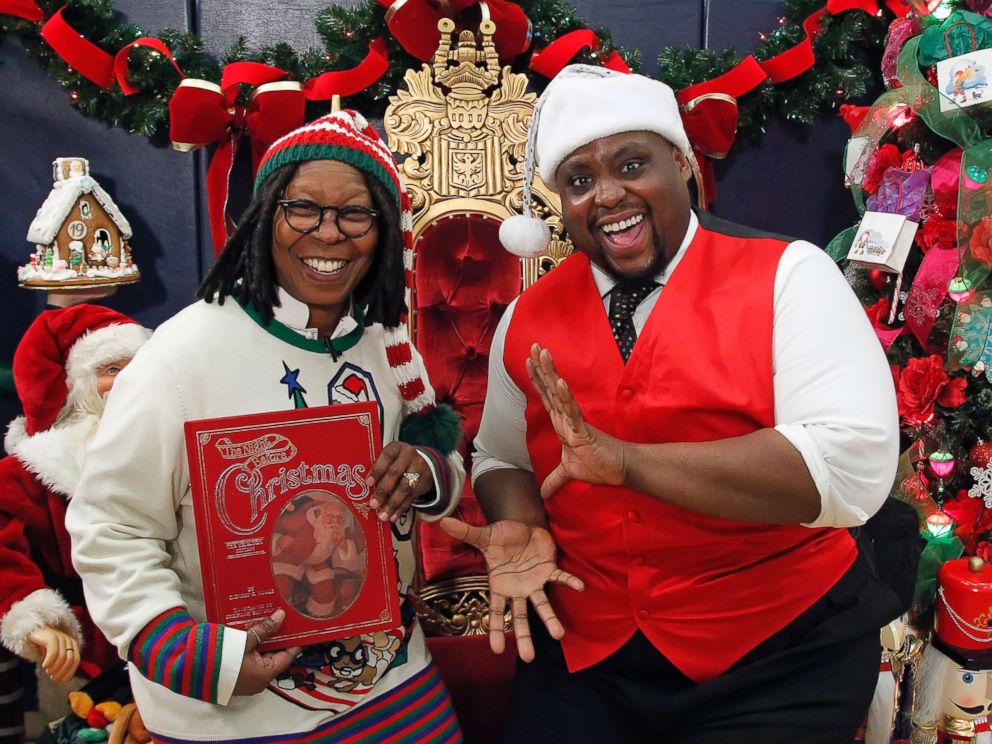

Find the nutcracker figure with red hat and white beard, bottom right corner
[[912, 556, 992, 744]]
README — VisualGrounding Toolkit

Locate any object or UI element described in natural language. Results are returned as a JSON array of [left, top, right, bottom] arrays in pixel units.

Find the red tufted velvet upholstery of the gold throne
[[414, 215, 521, 581]]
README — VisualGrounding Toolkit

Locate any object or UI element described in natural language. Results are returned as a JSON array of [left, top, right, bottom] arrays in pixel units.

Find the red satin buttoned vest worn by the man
[[503, 219, 857, 681]]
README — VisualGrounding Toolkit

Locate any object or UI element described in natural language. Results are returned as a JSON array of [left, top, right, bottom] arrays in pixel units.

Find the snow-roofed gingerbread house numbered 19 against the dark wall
[[17, 157, 141, 290]]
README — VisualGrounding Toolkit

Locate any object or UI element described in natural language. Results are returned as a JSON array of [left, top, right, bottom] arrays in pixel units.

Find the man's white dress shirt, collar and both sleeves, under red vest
[[472, 214, 899, 527]]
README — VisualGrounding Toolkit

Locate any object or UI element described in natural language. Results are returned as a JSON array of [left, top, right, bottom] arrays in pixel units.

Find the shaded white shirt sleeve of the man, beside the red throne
[[472, 300, 534, 485]]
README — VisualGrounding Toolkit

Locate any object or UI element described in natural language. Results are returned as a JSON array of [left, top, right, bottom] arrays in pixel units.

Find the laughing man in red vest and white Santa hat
[[443, 66, 898, 744]]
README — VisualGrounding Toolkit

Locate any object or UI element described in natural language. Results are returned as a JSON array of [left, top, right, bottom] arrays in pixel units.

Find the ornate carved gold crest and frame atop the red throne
[[383, 14, 571, 312]]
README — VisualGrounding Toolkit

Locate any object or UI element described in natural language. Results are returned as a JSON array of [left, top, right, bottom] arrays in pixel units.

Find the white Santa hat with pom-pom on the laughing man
[[499, 65, 691, 257]]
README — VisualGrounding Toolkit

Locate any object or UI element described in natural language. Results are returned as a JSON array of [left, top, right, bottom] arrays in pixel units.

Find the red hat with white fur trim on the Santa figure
[[13, 304, 150, 436]]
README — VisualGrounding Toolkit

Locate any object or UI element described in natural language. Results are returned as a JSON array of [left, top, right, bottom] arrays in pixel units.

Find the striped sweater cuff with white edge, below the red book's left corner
[[128, 607, 245, 705]]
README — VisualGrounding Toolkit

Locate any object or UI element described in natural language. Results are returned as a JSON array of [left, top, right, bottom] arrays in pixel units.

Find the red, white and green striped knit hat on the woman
[[255, 109, 461, 453]]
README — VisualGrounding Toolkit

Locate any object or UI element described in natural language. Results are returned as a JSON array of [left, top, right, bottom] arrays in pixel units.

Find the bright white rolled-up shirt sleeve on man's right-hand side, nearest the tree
[[773, 241, 899, 527]]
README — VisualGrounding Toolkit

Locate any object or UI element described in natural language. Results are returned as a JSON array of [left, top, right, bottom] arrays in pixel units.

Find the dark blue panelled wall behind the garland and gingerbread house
[[0, 0, 856, 422]]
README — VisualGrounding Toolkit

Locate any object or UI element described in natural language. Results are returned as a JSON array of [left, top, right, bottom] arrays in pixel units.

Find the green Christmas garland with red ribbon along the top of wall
[[0, 0, 889, 140]]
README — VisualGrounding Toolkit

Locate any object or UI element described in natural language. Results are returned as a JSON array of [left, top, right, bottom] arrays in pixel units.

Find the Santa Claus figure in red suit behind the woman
[[0, 304, 149, 713]]
